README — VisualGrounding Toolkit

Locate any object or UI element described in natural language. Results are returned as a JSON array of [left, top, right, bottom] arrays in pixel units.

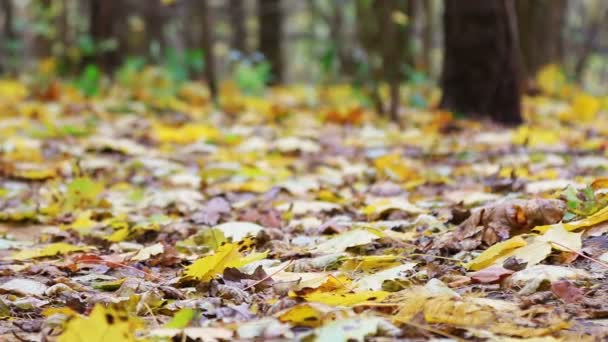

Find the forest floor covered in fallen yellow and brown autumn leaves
[[0, 75, 608, 341]]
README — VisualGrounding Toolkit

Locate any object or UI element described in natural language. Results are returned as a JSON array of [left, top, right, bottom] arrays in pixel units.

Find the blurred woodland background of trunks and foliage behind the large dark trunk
[[0, 0, 608, 108]]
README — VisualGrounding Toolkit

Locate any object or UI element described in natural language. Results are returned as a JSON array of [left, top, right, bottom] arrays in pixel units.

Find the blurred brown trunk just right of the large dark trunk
[[515, 0, 567, 78]]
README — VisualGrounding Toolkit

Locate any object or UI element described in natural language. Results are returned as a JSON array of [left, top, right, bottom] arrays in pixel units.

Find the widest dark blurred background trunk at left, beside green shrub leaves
[[89, 0, 121, 72]]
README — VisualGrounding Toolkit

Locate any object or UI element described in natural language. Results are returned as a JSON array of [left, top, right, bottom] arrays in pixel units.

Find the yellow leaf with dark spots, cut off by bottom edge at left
[[58, 304, 142, 342]]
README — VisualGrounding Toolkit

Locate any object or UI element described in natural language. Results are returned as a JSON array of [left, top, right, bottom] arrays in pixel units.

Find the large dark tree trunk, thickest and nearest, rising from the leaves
[[441, 0, 522, 124]]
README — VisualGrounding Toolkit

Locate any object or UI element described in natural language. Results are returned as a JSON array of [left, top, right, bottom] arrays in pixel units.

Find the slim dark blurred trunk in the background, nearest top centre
[[258, 0, 284, 84]]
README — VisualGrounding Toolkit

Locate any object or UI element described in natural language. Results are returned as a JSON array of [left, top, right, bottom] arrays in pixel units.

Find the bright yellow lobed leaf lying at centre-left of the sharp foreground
[[184, 243, 268, 281]]
